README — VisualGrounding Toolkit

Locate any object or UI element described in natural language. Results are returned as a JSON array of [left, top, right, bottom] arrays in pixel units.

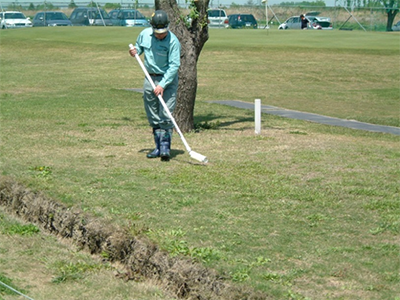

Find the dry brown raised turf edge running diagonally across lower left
[[0, 177, 268, 300]]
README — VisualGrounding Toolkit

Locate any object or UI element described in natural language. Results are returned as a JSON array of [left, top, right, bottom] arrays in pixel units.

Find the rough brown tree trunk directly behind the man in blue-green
[[155, 0, 209, 132]]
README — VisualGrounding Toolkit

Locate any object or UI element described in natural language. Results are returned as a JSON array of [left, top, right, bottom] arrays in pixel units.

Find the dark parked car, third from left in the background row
[[69, 7, 112, 26]]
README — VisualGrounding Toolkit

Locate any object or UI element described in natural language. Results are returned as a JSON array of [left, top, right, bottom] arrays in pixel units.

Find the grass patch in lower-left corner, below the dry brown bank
[[0, 213, 172, 300]]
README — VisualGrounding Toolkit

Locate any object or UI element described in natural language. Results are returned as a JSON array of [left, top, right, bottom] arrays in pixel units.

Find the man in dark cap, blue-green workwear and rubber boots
[[129, 10, 181, 161]]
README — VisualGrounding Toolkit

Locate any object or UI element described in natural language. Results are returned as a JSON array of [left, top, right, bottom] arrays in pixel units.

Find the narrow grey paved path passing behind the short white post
[[208, 100, 400, 135]]
